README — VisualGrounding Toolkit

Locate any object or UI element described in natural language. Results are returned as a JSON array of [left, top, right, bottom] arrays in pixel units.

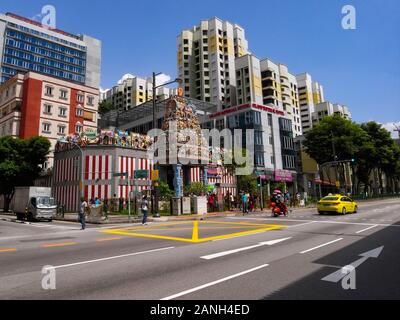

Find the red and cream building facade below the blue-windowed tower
[[0, 72, 99, 169]]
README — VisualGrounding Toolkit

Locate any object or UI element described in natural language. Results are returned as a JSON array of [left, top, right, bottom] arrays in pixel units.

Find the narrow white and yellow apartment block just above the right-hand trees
[[296, 73, 325, 133]]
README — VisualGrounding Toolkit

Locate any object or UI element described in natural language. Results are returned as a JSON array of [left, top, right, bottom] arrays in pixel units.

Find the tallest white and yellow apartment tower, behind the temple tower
[[177, 18, 248, 109]]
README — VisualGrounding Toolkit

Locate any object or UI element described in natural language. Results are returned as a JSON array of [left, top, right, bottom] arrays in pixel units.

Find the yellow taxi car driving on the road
[[317, 194, 358, 215]]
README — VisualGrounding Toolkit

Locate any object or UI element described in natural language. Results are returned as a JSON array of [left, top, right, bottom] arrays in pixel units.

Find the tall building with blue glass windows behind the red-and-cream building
[[0, 13, 101, 88]]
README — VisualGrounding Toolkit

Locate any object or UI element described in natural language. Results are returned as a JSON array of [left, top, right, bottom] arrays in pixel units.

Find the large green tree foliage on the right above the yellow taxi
[[304, 115, 400, 194]]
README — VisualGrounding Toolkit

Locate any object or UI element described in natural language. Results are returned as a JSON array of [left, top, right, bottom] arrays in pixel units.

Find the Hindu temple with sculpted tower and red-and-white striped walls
[[52, 97, 236, 210]]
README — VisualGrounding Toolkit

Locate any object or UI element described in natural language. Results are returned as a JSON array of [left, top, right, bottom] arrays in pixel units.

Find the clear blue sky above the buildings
[[0, 0, 400, 122]]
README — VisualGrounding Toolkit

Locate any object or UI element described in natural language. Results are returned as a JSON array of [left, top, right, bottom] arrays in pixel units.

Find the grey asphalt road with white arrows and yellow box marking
[[0, 199, 400, 300]]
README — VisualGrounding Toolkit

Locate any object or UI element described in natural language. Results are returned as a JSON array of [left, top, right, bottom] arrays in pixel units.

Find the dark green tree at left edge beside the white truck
[[0, 136, 51, 212]]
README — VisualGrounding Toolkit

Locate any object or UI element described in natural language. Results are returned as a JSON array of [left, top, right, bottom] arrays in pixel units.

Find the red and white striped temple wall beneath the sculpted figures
[[53, 146, 236, 212]]
